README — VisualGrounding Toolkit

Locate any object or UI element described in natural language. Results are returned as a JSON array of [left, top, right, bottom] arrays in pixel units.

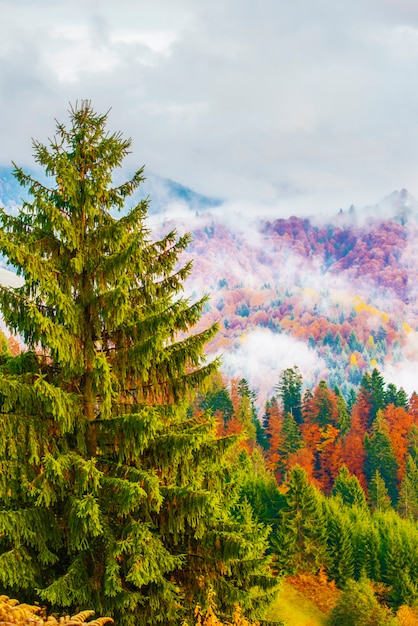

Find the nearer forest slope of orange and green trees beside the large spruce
[[192, 367, 418, 624]]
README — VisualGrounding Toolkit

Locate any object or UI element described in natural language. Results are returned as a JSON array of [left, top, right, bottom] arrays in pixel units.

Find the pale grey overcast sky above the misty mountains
[[0, 0, 418, 215]]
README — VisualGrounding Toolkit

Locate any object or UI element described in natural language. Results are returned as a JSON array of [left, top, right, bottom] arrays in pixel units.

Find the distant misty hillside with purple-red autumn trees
[[169, 191, 418, 399]]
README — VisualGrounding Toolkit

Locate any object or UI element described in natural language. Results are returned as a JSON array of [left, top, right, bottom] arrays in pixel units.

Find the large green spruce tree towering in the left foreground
[[0, 101, 271, 625]]
